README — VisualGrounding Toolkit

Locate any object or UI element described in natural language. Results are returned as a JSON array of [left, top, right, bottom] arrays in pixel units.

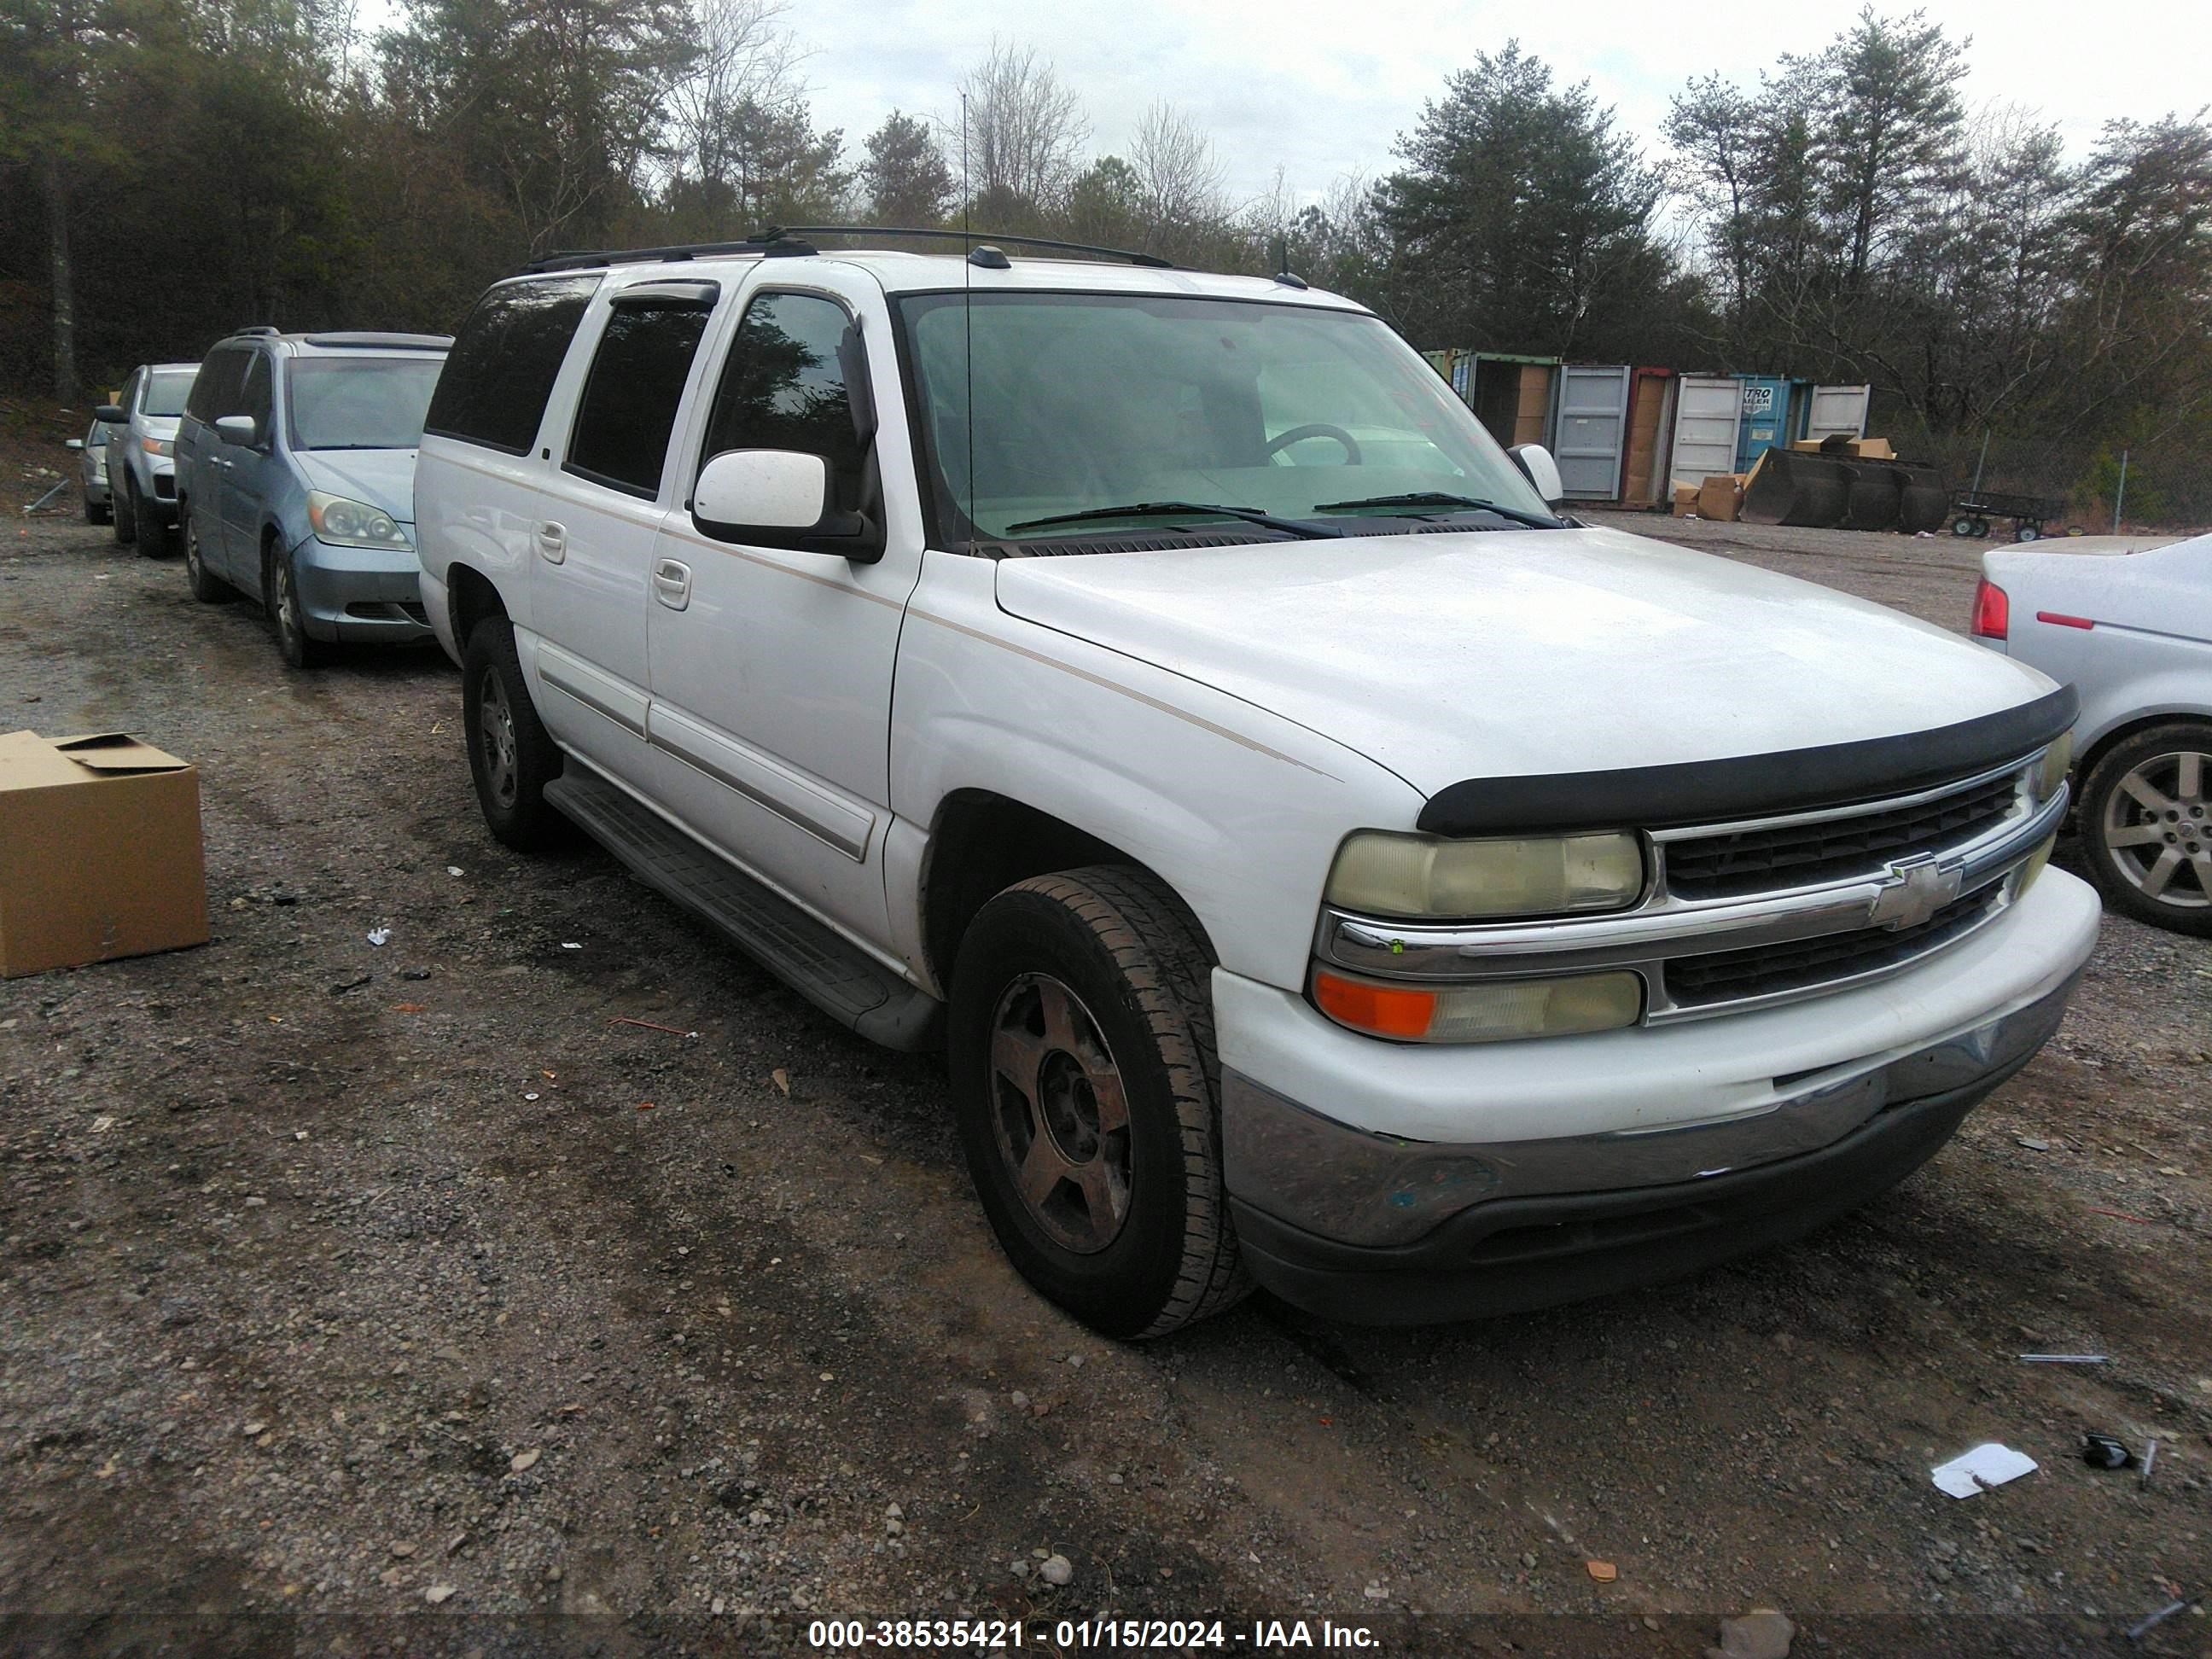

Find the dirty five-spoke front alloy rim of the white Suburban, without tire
[[991, 973, 1131, 1256]]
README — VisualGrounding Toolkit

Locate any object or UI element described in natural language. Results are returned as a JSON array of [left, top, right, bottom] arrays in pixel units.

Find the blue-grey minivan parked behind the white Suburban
[[177, 328, 453, 668]]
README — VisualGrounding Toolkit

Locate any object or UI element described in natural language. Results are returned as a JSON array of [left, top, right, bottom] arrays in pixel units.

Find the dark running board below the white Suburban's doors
[[546, 754, 945, 1051]]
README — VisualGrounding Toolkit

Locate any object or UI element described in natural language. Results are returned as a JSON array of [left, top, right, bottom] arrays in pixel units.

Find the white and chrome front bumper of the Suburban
[[1217, 871, 2097, 1323]]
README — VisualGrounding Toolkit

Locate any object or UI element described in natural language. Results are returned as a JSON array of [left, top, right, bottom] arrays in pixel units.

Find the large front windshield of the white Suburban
[[898, 292, 1551, 546]]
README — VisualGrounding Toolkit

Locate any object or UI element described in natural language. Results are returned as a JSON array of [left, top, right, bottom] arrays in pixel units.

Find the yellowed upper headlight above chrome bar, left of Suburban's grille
[[1330, 830, 1644, 918]]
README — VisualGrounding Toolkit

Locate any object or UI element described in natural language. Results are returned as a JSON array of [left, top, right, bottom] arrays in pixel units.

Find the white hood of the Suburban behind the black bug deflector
[[998, 528, 2051, 795]]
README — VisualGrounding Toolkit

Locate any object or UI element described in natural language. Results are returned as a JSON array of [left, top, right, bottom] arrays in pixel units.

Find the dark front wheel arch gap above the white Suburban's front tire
[[920, 789, 1221, 999]]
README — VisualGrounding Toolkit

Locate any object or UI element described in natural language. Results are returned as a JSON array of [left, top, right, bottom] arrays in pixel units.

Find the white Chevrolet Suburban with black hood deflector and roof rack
[[416, 235, 2097, 1336]]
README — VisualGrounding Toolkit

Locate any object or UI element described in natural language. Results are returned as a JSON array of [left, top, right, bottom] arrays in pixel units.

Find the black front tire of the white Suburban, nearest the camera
[[946, 864, 1252, 1338]]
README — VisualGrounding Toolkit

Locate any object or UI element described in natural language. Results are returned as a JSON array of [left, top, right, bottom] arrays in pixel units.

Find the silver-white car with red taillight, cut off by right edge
[[1973, 535, 2212, 935]]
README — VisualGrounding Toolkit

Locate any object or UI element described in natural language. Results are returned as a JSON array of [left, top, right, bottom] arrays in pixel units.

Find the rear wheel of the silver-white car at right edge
[[2079, 721, 2212, 938]]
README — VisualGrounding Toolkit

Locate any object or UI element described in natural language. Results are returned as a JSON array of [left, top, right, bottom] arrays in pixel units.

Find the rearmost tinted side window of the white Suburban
[[425, 272, 599, 456]]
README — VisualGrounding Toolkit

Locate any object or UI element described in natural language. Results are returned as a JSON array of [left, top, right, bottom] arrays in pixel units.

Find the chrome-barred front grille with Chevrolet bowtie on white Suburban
[[1316, 754, 2066, 1024]]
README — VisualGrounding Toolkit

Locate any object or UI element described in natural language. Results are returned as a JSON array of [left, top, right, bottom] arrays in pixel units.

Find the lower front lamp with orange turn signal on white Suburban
[[1314, 969, 1644, 1042]]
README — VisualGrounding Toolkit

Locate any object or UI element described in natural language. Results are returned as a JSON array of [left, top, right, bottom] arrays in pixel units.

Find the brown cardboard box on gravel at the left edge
[[0, 732, 208, 980]]
